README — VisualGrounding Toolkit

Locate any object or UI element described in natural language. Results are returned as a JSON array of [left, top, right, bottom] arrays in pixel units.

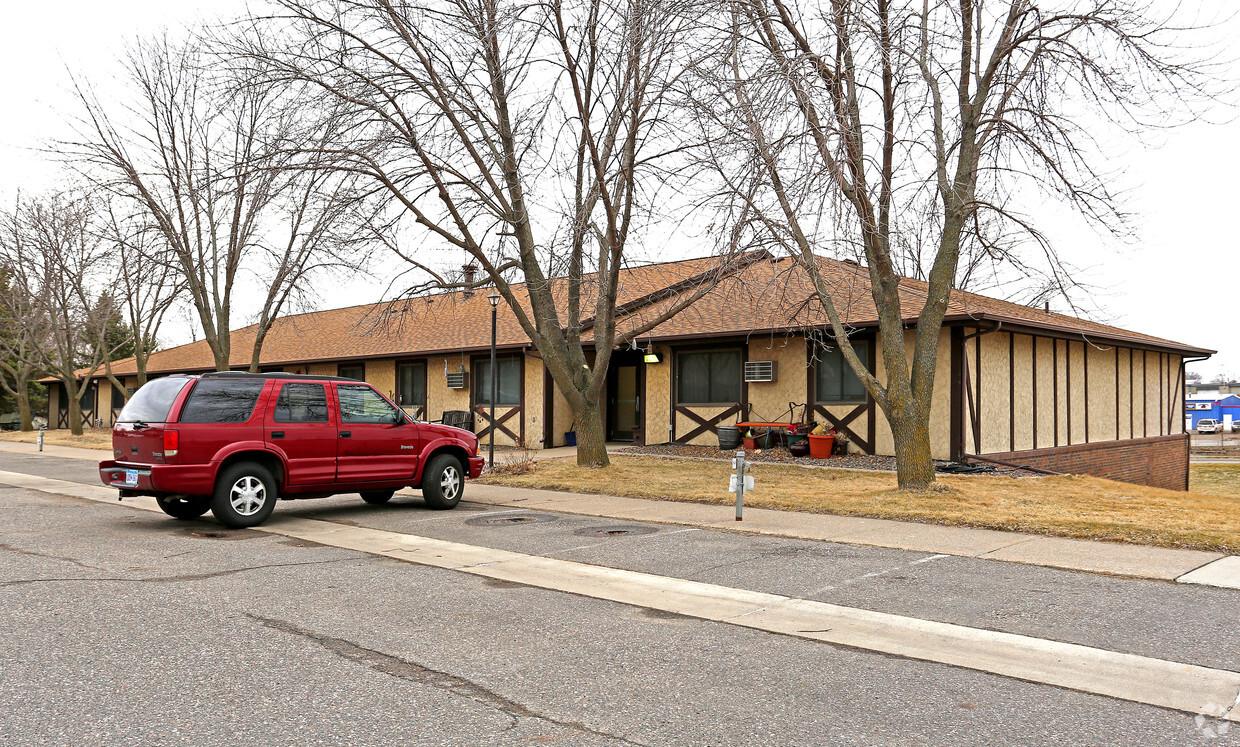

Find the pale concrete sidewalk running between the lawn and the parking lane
[[0, 442, 1240, 589]]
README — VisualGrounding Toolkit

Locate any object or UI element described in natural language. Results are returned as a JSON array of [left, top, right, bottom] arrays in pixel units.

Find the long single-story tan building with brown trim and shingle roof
[[50, 253, 1214, 489]]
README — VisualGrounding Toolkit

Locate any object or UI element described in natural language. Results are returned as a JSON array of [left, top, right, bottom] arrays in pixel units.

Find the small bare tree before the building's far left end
[[0, 191, 113, 434]]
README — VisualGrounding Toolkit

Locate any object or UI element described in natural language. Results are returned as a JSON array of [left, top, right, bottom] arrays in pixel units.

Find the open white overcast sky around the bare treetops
[[0, 0, 1240, 378]]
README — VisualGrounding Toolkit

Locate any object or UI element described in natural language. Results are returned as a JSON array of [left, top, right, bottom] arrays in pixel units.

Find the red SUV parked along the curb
[[99, 372, 484, 527]]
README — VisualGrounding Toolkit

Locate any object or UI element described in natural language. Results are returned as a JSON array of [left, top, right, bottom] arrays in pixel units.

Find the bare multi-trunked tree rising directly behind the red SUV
[[61, 37, 367, 371]]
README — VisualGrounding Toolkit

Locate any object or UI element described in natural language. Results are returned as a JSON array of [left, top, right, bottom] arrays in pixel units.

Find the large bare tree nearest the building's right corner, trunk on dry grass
[[697, 0, 1208, 489]]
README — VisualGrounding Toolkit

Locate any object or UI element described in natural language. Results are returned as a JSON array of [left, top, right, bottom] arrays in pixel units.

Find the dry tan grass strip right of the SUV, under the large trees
[[482, 457, 1240, 553]]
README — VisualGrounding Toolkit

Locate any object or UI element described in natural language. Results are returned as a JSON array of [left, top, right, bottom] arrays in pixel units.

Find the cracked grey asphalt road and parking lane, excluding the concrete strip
[[0, 453, 1240, 745]]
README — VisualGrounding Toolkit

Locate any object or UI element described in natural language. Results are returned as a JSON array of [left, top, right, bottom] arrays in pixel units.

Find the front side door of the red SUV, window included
[[336, 383, 420, 483]]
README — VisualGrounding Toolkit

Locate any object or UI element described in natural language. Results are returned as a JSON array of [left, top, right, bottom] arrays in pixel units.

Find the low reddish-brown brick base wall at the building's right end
[[981, 434, 1188, 490]]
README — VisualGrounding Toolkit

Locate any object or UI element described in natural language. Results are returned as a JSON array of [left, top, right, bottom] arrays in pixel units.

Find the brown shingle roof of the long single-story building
[[67, 257, 1213, 376]]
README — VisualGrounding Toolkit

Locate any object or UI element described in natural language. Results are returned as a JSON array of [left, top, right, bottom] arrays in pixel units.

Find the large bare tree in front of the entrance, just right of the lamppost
[[246, 0, 734, 465]]
